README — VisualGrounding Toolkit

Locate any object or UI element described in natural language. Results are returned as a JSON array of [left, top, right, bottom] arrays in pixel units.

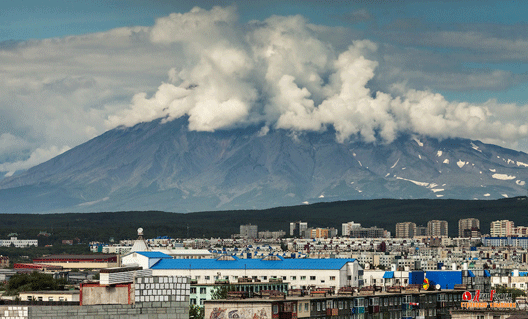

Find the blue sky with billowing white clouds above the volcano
[[0, 0, 528, 176]]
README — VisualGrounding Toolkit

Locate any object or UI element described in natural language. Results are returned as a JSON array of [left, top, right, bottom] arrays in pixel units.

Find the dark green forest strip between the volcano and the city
[[0, 197, 528, 244]]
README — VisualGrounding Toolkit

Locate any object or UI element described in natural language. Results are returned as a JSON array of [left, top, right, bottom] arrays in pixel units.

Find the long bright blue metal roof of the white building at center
[[151, 259, 355, 270]]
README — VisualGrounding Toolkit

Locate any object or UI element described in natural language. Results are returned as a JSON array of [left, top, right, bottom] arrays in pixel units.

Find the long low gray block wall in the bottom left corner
[[0, 301, 189, 319]]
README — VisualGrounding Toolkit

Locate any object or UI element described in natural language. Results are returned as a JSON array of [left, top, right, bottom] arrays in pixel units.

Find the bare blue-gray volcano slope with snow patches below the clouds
[[0, 118, 528, 213]]
